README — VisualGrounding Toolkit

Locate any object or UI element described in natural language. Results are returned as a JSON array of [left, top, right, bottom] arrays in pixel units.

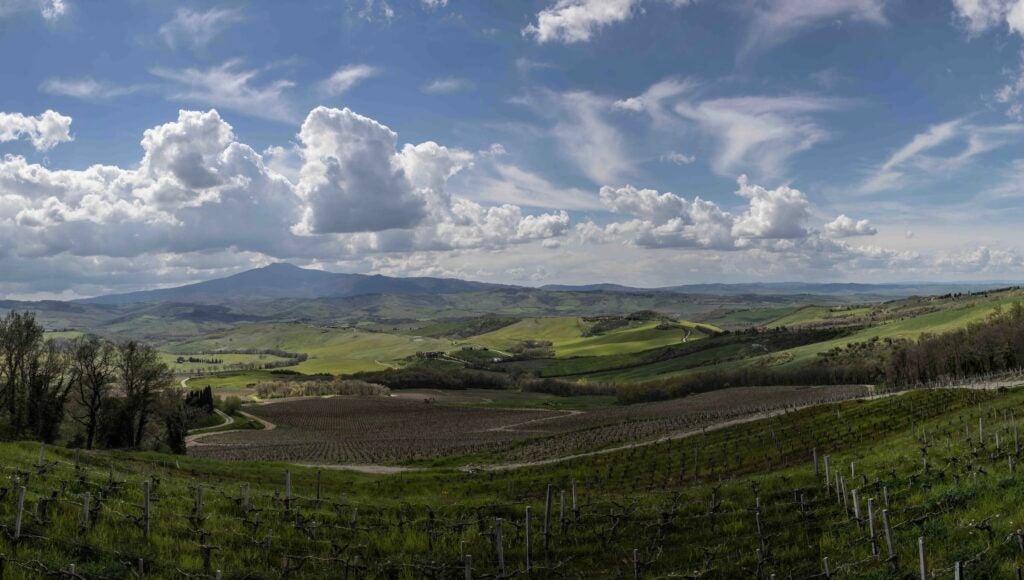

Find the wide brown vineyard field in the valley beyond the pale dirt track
[[189, 386, 868, 464]]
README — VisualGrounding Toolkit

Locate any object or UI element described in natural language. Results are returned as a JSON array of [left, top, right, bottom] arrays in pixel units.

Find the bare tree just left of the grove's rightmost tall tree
[[71, 336, 117, 449]]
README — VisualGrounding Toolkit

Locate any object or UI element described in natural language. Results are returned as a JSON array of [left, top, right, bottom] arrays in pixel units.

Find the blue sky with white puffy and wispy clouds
[[0, 0, 1024, 299]]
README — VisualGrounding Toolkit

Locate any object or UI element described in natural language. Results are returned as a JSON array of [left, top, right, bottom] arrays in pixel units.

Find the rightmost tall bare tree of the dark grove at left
[[115, 340, 173, 447]]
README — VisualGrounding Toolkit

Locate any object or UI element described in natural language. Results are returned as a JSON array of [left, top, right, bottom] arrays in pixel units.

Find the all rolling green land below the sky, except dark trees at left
[[0, 267, 1024, 578]]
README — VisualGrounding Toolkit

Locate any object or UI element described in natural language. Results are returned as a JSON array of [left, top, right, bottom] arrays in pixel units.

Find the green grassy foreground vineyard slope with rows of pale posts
[[0, 389, 1024, 578]]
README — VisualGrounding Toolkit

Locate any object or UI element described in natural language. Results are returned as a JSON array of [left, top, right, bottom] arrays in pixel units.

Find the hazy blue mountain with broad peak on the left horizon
[[78, 263, 508, 304]]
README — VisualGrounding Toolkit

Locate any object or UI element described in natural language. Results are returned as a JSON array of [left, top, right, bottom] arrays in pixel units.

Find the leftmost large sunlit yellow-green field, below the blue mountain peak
[[167, 323, 452, 374]]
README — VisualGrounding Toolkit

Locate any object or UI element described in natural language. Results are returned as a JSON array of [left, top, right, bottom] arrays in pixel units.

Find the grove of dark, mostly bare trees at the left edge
[[0, 312, 189, 451]]
